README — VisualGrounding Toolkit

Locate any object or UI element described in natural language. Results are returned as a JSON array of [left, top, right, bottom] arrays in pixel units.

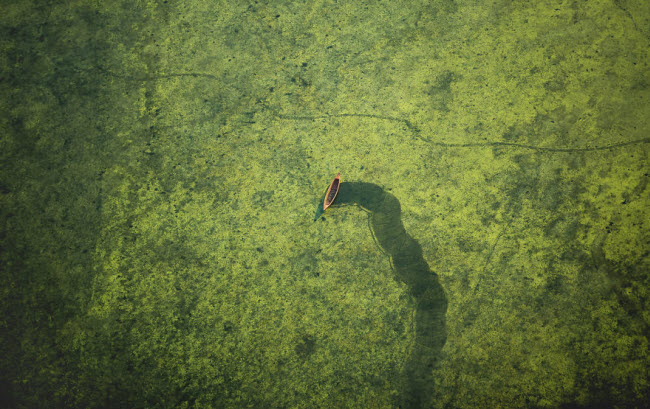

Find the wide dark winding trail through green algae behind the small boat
[[336, 182, 447, 408]]
